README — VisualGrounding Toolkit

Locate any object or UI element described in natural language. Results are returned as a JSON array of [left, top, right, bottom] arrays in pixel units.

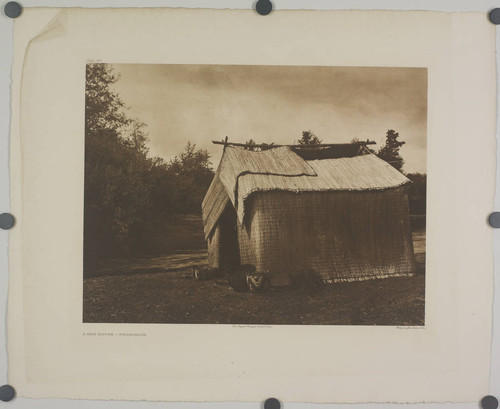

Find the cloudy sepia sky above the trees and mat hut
[[113, 64, 427, 173]]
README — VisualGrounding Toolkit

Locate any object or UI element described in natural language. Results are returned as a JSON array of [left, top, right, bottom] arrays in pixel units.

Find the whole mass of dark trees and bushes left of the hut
[[84, 64, 213, 263]]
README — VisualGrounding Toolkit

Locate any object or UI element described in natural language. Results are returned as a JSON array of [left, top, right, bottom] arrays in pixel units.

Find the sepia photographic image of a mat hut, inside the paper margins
[[83, 63, 428, 326]]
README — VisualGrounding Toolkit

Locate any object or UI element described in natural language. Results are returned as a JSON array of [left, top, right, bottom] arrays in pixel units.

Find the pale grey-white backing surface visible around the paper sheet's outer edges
[[0, 0, 500, 409]]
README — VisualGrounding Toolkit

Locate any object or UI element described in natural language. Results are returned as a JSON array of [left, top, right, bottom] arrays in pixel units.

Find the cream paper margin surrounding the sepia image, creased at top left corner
[[8, 9, 496, 402]]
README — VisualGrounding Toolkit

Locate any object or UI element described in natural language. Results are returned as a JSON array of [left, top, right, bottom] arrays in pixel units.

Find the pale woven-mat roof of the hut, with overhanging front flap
[[202, 146, 411, 238]]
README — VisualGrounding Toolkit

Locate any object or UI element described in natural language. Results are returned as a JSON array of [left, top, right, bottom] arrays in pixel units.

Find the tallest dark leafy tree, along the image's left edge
[[84, 64, 152, 259]]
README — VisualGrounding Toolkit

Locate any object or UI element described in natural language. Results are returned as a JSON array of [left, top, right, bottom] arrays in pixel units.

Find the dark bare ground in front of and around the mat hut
[[83, 230, 425, 326]]
